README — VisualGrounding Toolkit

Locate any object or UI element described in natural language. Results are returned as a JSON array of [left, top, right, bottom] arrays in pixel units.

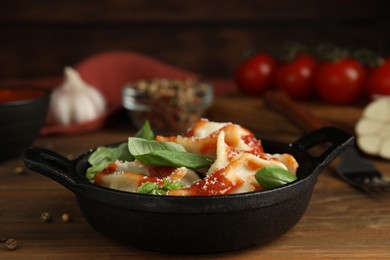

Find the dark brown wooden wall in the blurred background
[[0, 0, 390, 79]]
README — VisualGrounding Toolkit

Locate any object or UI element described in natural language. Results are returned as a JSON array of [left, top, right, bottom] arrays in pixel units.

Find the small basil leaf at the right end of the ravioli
[[255, 165, 297, 189]]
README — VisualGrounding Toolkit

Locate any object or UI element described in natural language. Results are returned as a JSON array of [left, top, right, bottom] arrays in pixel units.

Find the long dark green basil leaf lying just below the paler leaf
[[134, 150, 214, 169]]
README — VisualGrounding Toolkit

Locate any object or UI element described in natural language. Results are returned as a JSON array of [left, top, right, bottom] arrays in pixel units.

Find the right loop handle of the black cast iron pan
[[291, 127, 355, 166]]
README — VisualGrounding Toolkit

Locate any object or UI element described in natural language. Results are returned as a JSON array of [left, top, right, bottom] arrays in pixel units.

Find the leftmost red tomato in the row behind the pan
[[234, 53, 276, 95]]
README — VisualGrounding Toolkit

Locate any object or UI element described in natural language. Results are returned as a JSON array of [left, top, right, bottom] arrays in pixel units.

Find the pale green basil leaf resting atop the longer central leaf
[[128, 137, 185, 156]]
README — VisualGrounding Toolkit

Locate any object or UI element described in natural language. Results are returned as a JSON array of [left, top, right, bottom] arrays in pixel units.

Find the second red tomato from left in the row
[[275, 54, 317, 99]]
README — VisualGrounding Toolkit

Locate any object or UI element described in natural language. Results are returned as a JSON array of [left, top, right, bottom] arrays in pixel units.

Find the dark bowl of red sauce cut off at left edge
[[0, 87, 50, 161]]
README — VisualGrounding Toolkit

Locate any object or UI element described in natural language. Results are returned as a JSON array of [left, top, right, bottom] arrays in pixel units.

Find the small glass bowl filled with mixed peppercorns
[[122, 79, 214, 133]]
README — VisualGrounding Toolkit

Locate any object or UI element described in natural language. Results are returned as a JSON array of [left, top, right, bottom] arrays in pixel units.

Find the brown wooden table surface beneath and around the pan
[[0, 96, 390, 260]]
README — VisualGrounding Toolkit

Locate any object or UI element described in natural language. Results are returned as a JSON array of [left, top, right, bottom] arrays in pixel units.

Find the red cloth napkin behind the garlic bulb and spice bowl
[[0, 51, 236, 135]]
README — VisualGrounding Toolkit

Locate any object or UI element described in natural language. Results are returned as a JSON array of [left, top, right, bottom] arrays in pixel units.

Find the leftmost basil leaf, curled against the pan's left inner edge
[[86, 143, 134, 180]]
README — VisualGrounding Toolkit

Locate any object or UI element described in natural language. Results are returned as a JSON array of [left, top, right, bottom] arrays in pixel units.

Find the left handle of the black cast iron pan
[[23, 146, 82, 191]]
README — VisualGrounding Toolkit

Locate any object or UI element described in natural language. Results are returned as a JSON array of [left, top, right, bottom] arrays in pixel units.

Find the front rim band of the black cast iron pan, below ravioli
[[74, 161, 316, 214]]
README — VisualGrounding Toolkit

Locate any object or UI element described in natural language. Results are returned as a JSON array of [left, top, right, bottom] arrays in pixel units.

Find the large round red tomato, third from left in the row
[[315, 58, 367, 105]]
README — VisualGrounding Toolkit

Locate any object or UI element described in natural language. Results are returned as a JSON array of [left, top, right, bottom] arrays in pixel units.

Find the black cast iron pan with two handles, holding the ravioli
[[24, 127, 354, 253]]
